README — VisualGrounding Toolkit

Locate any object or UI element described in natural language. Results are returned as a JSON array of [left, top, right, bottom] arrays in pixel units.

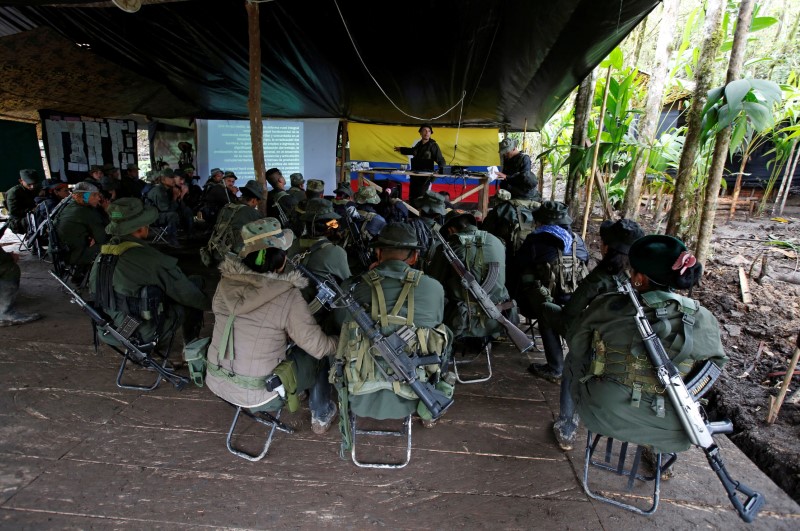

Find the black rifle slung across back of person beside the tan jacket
[[295, 264, 453, 420]]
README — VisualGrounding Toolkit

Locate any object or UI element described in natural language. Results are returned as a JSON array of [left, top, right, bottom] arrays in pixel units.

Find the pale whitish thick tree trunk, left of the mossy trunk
[[622, 0, 678, 219]]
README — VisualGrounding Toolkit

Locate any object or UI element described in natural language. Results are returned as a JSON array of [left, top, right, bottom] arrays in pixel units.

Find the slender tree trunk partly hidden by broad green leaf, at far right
[[695, 0, 755, 264]]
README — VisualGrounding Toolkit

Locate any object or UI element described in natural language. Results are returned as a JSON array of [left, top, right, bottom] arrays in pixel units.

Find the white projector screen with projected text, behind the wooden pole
[[196, 119, 339, 195]]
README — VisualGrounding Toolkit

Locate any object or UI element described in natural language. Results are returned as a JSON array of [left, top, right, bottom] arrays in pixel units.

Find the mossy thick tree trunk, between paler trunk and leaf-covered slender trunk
[[666, 0, 723, 239]]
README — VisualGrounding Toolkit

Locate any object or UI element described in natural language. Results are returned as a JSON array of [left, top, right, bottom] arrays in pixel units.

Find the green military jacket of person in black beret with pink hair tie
[[566, 292, 728, 452]]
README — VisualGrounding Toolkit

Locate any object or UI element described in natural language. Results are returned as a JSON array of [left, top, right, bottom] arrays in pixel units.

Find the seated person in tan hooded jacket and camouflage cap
[[205, 218, 337, 433]]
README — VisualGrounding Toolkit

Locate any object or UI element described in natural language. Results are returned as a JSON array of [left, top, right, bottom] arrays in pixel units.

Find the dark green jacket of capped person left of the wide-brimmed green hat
[[54, 201, 108, 265]]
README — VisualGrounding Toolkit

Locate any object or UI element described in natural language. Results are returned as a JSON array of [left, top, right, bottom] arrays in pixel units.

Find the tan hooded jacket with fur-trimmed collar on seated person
[[206, 257, 338, 407]]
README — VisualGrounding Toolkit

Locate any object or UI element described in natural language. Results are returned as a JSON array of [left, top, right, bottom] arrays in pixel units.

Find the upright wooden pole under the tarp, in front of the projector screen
[[245, 2, 267, 214]]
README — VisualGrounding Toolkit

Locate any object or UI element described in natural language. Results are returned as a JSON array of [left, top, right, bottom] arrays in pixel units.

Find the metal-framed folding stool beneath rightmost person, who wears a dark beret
[[583, 431, 678, 516]]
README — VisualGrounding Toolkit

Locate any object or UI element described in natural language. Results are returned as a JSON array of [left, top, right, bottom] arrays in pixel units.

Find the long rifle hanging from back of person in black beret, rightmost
[[617, 279, 764, 523]]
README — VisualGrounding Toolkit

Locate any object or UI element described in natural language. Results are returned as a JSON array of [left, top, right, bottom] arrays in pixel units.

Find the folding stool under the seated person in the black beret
[[583, 431, 678, 516]]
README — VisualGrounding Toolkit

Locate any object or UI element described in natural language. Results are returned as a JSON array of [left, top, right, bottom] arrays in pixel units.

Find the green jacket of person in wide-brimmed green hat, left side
[[89, 235, 211, 340]]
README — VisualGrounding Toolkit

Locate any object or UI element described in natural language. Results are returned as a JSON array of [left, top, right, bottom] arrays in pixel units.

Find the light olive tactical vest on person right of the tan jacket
[[336, 269, 448, 400]]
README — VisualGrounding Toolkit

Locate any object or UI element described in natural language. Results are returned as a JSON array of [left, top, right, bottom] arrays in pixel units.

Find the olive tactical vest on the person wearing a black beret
[[581, 291, 700, 417]]
